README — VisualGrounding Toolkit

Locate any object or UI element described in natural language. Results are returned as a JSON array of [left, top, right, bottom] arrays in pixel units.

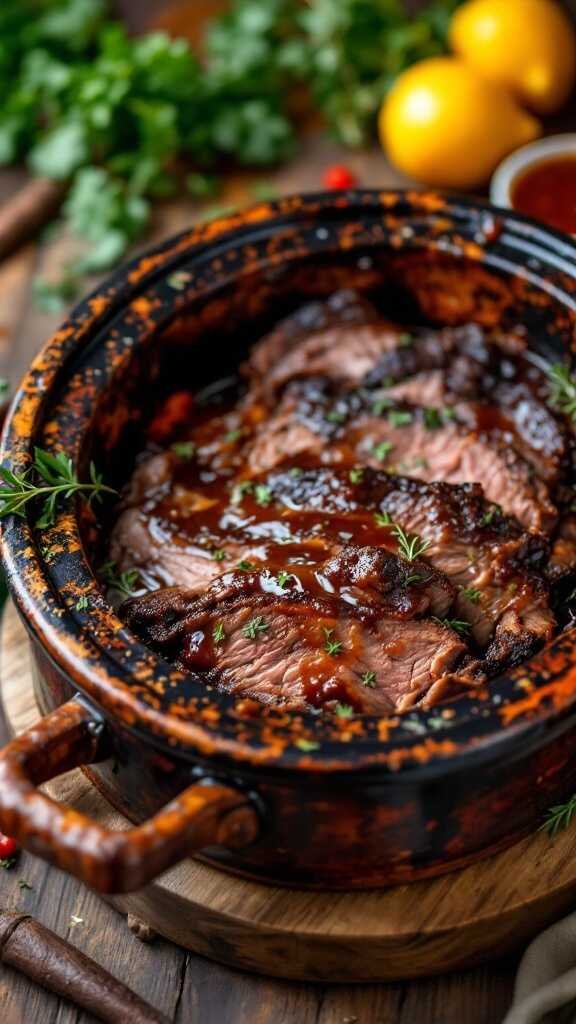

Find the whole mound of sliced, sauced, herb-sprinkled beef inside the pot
[[110, 292, 576, 717]]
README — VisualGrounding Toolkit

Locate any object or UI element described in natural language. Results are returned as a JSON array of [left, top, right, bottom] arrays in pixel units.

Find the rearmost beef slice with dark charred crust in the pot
[[249, 304, 568, 499]]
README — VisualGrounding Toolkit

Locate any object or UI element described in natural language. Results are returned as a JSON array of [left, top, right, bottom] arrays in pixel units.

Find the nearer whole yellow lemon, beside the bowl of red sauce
[[379, 57, 541, 188]]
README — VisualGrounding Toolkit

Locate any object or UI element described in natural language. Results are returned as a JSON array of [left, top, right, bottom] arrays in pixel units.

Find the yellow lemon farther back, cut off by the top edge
[[450, 0, 576, 114]]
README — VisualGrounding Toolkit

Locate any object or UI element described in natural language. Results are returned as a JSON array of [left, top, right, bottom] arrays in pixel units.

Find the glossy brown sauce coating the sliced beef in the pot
[[114, 307, 565, 708]]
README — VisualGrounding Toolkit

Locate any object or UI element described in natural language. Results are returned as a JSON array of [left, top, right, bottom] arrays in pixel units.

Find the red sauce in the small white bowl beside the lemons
[[511, 154, 576, 234]]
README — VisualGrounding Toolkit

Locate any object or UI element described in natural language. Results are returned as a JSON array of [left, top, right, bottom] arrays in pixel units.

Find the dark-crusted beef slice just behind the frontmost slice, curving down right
[[259, 468, 556, 668]]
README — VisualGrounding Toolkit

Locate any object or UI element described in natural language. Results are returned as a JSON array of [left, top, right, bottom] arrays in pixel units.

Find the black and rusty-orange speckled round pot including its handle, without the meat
[[0, 191, 576, 891]]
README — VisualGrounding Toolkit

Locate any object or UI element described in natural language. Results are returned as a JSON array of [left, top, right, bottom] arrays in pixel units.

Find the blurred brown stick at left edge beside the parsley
[[0, 178, 66, 259]]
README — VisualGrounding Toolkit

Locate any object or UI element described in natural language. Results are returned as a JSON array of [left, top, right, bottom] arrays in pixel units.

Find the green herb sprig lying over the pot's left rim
[[0, 447, 118, 529]]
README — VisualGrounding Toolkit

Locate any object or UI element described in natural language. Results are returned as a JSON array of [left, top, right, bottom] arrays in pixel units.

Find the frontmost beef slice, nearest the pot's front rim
[[124, 549, 475, 714]]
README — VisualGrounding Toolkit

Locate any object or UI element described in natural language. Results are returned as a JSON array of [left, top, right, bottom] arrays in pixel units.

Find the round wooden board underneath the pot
[[0, 605, 576, 982]]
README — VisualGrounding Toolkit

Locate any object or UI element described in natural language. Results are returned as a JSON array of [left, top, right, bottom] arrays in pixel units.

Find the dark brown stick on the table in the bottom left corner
[[0, 911, 168, 1024]]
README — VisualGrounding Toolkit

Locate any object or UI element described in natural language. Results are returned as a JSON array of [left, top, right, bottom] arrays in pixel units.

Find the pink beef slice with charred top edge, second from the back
[[247, 382, 558, 532]]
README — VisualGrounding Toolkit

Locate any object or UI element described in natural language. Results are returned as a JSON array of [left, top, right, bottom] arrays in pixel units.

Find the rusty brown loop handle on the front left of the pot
[[0, 697, 258, 893]]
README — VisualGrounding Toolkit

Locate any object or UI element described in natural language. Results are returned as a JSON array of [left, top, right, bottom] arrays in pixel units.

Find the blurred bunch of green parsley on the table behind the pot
[[0, 0, 456, 308]]
